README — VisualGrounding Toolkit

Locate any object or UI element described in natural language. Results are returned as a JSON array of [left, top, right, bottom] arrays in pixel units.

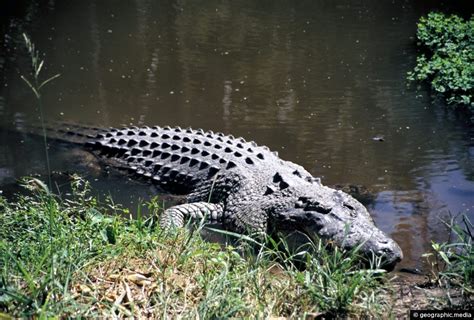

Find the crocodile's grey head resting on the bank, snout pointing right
[[271, 186, 403, 271]]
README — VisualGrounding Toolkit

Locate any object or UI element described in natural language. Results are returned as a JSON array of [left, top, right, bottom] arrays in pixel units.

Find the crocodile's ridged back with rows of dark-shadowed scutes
[[87, 127, 292, 194]]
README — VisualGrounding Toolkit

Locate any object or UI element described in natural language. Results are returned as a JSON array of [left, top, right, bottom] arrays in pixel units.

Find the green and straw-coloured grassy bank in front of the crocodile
[[0, 177, 390, 319]]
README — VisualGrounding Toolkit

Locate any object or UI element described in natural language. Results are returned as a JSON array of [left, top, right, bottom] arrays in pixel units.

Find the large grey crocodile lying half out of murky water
[[51, 126, 403, 270]]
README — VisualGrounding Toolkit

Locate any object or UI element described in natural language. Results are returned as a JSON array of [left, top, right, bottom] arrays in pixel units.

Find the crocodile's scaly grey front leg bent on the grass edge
[[160, 202, 224, 229]]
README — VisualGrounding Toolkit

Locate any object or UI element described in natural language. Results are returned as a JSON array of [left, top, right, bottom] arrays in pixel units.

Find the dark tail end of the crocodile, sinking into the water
[[24, 122, 107, 146]]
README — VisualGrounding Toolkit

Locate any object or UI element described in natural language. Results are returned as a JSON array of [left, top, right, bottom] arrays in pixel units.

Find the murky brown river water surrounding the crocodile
[[0, 0, 474, 267]]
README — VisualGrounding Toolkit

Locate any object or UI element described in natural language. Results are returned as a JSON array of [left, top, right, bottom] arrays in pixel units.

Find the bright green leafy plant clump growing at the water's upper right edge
[[408, 12, 474, 117]]
